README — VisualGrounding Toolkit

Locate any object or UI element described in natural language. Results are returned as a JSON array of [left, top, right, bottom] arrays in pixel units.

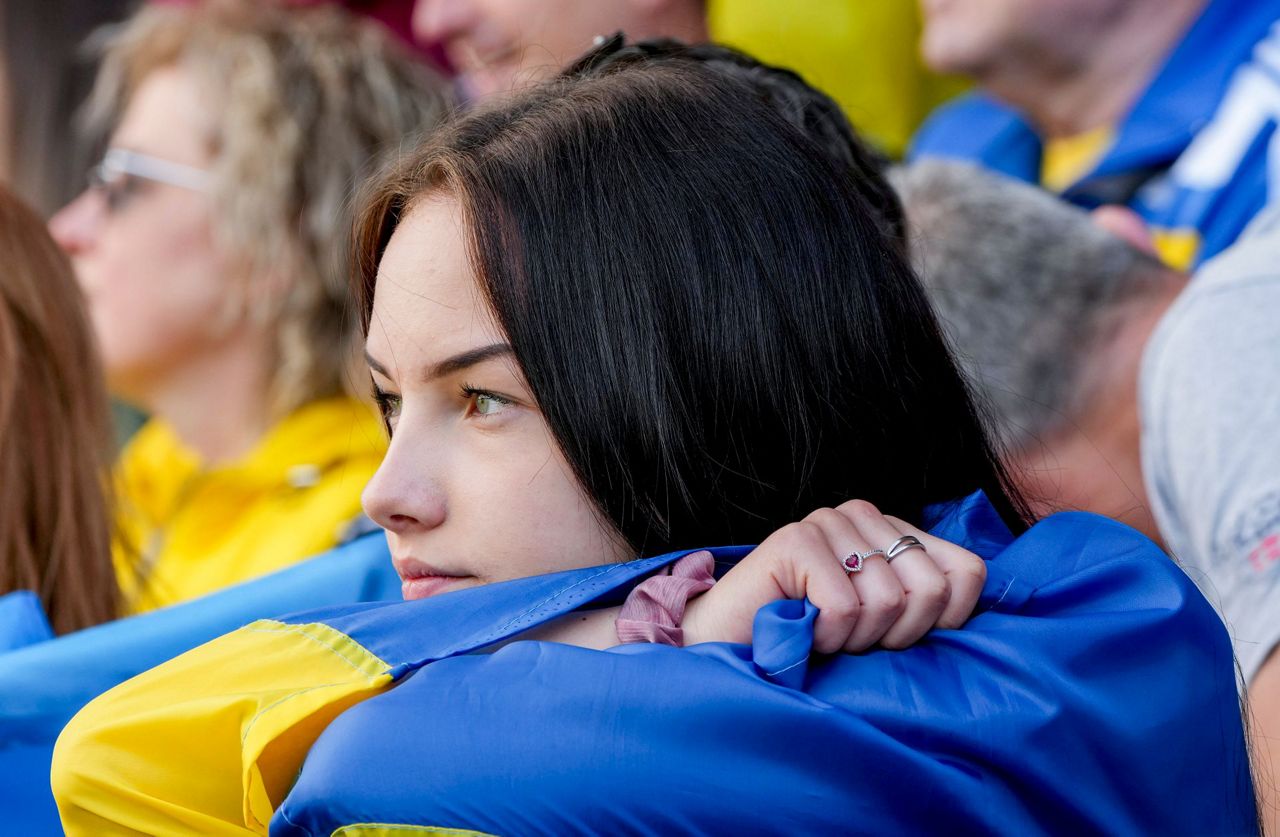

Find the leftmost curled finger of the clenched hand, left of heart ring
[[795, 508, 861, 654]]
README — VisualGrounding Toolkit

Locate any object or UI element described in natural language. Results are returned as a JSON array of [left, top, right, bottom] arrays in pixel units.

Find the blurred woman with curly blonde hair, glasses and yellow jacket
[[51, 3, 445, 610]]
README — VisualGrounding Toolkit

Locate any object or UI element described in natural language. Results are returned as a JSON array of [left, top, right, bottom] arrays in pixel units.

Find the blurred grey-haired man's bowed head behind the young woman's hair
[[892, 161, 1187, 545]]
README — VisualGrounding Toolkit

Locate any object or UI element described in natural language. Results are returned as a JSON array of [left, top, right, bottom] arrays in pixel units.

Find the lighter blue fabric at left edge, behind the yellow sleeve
[[0, 531, 399, 834]]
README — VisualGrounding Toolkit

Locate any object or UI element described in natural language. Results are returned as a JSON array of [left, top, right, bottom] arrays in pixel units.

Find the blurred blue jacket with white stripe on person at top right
[[910, 0, 1280, 267]]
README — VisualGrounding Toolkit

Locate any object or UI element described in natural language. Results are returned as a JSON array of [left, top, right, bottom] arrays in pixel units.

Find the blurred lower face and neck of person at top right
[[920, 0, 1206, 137]]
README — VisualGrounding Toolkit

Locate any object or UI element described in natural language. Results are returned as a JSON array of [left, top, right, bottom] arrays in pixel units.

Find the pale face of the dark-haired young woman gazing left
[[365, 196, 631, 599]]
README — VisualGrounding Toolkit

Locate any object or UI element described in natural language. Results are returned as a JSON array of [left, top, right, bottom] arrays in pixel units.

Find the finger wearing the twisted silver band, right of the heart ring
[[846, 503, 950, 649]]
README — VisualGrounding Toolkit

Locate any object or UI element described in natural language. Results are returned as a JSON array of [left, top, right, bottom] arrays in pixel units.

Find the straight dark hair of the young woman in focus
[[356, 61, 1023, 553]]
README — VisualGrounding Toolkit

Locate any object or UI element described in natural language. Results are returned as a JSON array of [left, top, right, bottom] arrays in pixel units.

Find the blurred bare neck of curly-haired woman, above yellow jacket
[[131, 338, 271, 467]]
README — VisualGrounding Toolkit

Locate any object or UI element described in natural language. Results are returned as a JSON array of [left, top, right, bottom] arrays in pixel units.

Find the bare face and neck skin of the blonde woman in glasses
[[50, 68, 273, 462]]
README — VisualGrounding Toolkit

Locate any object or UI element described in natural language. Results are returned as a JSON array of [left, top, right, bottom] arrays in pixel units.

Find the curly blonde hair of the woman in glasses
[[86, 0, 448, 416]]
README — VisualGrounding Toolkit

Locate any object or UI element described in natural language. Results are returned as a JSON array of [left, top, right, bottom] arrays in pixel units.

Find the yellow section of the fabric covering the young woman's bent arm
[[51, 619, 392, 836]]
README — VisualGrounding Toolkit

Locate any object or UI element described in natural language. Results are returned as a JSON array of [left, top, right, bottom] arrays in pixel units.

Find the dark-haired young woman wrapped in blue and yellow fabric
[[52, 60, 1256, 834]]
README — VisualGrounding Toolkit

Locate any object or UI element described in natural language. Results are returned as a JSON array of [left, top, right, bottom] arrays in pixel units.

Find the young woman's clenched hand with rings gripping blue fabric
[[684, 500, 987, 654]]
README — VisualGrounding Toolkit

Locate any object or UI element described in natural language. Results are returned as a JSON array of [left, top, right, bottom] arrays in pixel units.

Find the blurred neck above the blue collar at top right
[[979, 0, 1208, 140]]
